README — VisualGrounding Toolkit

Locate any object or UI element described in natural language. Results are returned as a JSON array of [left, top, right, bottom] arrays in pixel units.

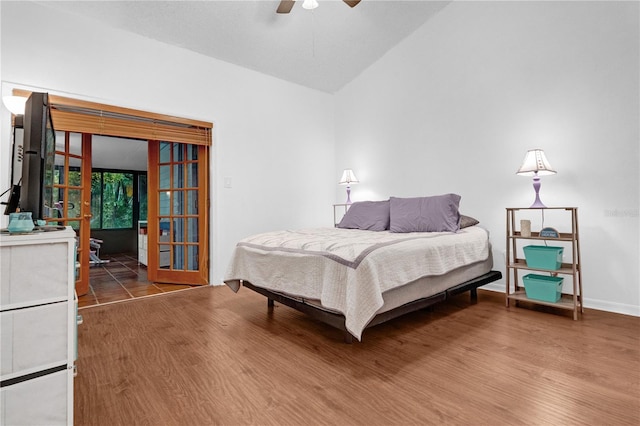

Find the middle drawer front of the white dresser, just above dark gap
[[0, 302, 69, 379]]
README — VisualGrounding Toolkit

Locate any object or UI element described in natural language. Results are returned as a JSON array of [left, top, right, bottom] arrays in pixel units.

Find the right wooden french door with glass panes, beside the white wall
[[147, 141, 209, 285]]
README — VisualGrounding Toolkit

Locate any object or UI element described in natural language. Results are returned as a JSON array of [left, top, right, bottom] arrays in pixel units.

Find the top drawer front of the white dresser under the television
[[0, 242, 70, 308]]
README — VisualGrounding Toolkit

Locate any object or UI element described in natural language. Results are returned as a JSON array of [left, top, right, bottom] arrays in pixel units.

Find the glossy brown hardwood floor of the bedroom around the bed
[[75, 286, 640, 425]]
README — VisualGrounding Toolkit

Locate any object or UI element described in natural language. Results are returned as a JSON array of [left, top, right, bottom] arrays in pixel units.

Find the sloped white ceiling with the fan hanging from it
[[36, 0, 450, 93]]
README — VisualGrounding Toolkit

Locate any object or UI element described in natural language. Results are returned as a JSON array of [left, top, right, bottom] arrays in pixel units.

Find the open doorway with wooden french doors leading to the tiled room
[[49, 131, 208, 298]]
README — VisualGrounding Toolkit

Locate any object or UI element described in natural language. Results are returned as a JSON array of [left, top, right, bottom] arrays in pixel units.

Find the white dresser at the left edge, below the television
[[0, 227, 76, 426]]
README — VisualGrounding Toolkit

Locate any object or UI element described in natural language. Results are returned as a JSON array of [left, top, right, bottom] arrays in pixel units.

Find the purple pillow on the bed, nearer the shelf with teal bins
[[389, 194, 461, 232]]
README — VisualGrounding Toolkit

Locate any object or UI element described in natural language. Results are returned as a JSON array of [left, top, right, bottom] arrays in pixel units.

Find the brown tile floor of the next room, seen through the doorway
[[78, 253, 192, 309]]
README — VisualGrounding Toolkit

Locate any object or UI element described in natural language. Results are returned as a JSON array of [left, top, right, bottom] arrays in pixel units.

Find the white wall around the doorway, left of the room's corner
[[0, 2, 336, 283]]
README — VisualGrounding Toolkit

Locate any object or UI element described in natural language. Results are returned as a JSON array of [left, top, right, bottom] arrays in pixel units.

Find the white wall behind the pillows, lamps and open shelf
[[336, 2, 640, 315]]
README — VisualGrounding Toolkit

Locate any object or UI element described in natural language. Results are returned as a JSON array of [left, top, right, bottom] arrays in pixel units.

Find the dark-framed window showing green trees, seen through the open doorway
[[91, 171, 136, 229]]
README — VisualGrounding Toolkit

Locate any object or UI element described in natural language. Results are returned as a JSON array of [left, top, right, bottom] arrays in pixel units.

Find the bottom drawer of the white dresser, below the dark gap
[[0, 370, 73, 426]]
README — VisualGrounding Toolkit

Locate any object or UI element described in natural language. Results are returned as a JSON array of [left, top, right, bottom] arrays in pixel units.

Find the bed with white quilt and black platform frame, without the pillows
[[224, 196, 502, 342]]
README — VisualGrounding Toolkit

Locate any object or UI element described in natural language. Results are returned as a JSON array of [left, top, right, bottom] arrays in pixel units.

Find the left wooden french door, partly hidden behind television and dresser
[[45, 131, 91, 296]]
